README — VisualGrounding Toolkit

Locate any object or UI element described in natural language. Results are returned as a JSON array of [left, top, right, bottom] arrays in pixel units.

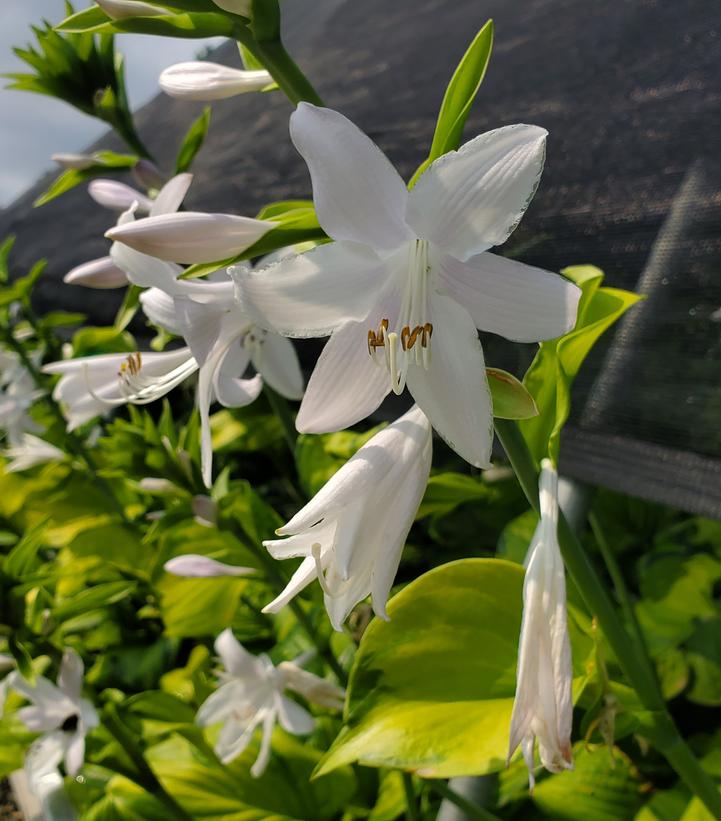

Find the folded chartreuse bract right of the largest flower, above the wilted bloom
[[520, 265, 641, 462]]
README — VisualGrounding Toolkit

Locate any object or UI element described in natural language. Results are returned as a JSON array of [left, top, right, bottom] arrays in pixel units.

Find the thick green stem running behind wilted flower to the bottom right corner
[[495, 419, 721, 819]]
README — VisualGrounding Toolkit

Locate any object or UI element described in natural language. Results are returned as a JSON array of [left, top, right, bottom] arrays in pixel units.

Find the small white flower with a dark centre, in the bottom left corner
[[8, 650, 99, 776]]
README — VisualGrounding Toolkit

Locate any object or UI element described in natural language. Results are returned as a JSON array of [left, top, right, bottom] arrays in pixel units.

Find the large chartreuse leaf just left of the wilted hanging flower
[[317, 559, 584, 778]]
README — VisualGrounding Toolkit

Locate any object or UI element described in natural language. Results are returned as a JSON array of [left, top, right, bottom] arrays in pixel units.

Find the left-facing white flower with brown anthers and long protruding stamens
[[43, 348, 198, 431]]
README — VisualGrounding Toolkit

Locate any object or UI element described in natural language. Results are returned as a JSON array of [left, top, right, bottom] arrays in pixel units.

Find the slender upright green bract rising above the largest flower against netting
[[408, 20, 493, 188]]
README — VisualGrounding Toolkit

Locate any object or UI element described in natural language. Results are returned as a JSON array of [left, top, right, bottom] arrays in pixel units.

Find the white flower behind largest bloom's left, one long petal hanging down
[[111, 231, 303, 486]]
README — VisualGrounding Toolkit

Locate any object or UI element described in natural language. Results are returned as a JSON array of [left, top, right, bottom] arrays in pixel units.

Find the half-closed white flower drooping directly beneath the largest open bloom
[[263, 407, 432, 630]]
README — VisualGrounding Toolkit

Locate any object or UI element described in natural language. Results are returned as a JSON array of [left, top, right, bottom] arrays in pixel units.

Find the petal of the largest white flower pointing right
[[438, 253, 581, 342]]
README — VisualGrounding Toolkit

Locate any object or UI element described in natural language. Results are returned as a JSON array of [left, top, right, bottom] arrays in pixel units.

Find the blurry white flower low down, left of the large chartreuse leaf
[[196, 629, 344, 778]]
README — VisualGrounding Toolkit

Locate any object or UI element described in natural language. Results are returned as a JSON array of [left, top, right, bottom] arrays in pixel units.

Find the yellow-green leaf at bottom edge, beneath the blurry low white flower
[[147, 730, 355, 821]]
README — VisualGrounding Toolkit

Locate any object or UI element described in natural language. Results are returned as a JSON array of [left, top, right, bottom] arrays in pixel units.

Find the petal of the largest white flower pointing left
[[229, 242, 386, 338]]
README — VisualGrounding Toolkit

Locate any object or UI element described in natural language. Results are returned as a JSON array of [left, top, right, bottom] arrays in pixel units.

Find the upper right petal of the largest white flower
[[406, 125, 547, 260]]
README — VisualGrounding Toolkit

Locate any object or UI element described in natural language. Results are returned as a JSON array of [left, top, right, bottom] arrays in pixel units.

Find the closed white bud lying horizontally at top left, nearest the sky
[[159, 60, 273, 101]]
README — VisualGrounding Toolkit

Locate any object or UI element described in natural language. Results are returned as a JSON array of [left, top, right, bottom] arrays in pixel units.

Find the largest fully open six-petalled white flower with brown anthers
[[233, 103, 581, 467]]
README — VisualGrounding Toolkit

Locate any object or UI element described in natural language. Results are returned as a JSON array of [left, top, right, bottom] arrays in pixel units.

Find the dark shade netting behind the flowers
[[0, 0, 721, 516]]
